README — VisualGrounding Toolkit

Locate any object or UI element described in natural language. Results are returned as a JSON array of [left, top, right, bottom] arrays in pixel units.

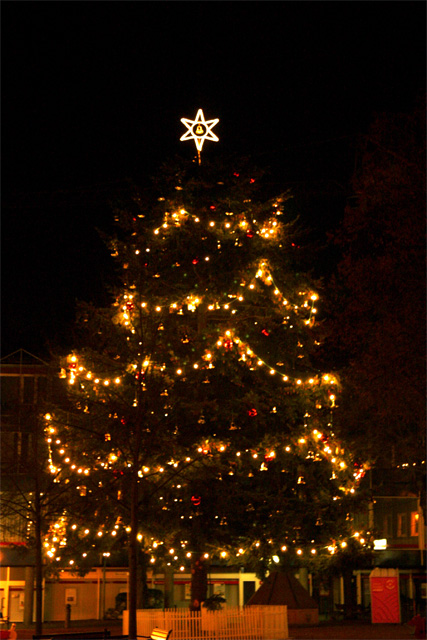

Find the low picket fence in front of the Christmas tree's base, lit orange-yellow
[[123, 605, 289, 640]]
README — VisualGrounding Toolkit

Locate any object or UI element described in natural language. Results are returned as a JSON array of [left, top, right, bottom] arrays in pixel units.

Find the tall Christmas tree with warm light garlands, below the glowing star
[[47, 152, 365, 636]]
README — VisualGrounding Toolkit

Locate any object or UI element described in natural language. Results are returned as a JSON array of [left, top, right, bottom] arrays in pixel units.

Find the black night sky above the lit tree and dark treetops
[[1, 0, 426, 355]]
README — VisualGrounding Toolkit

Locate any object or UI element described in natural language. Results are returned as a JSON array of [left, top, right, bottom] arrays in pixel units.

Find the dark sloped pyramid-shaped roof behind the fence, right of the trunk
[[246, 571, 318, 609]]
